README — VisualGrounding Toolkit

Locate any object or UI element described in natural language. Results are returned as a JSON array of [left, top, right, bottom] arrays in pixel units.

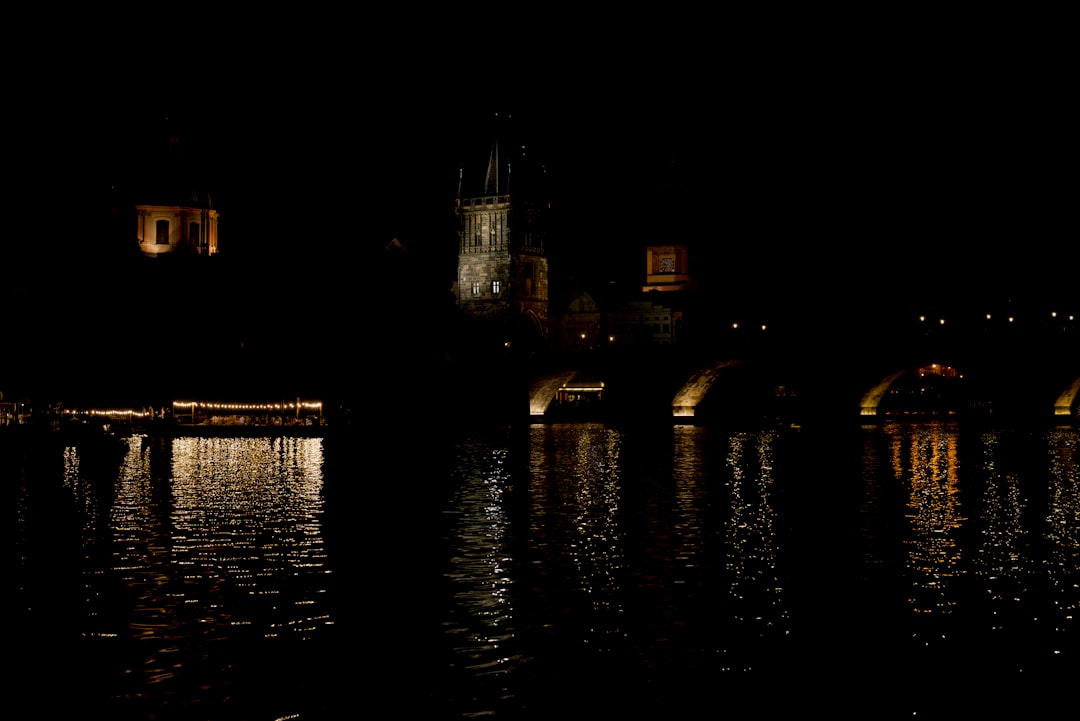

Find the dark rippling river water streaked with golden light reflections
[[8, 421, 1080, 721]]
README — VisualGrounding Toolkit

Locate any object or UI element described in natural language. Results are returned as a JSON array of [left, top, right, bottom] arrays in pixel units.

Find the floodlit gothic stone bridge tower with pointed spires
[[456, 122, 550, 342]]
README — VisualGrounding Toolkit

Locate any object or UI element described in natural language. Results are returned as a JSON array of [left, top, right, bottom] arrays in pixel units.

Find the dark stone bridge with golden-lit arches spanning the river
[[520, 330, 1080, 423]]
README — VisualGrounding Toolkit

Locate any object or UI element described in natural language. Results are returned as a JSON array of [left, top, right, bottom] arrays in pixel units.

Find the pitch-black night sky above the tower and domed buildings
[[0, 17, 1080, 399]]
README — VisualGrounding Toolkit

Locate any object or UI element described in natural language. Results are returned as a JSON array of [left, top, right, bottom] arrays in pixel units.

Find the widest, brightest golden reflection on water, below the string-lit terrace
[[171, 437, 330, 637]]
